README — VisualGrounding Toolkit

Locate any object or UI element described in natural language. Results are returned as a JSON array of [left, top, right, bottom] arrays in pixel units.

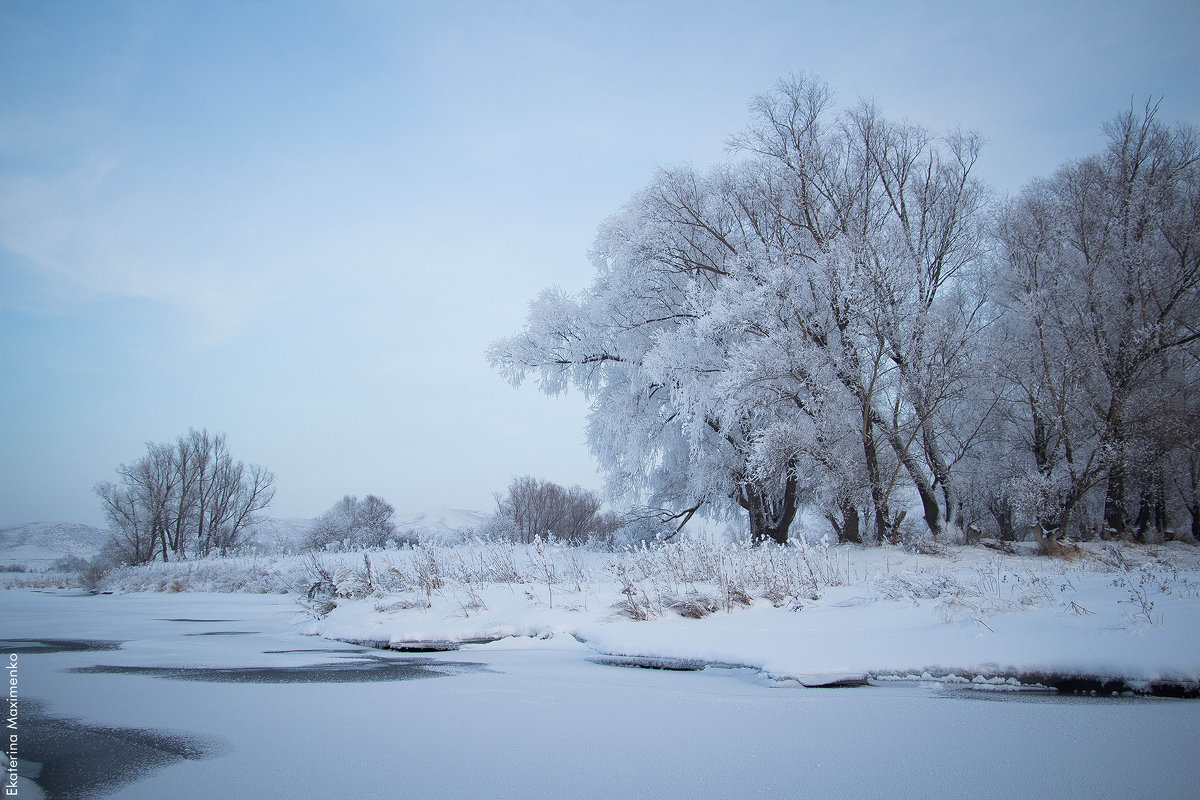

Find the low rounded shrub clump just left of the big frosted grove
[[486, 475, 622, 543]]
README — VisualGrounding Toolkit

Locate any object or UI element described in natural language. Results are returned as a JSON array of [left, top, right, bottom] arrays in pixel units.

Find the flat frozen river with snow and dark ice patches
[[0, 590, 1200, 800]]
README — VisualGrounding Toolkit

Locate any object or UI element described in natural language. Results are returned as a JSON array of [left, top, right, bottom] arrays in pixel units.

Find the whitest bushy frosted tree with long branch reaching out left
[[488, 170, 816, 540]]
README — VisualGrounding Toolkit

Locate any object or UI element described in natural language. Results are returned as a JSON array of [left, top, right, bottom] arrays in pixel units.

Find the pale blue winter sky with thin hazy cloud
[[0, 0, 1200, 525]]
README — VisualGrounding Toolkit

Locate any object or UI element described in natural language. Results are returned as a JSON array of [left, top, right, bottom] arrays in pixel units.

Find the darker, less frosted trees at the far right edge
[[1000, 106, 1200, 552]]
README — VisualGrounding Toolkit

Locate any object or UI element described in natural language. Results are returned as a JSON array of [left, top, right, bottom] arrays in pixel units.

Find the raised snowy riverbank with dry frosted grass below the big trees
[[307, 534, 1200, 691]]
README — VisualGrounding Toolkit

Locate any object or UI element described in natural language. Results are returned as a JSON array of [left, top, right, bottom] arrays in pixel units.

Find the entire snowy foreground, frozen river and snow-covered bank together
[[0, 541, 1200, 800]]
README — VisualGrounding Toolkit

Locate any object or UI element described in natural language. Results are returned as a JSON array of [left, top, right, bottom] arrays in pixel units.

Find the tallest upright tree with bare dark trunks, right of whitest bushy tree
[[737, 86, 985, 539]]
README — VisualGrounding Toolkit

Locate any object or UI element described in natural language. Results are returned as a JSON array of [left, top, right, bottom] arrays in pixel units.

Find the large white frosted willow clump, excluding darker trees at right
[[488, 77, 983, 542]]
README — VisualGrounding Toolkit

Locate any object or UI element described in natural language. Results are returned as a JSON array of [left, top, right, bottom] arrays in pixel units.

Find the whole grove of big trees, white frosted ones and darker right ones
[[488, 76, 1200, 552]]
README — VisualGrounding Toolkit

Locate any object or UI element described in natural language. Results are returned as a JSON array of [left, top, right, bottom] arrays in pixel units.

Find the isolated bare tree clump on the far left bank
[[95, 429, 275, 564]]
